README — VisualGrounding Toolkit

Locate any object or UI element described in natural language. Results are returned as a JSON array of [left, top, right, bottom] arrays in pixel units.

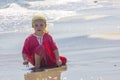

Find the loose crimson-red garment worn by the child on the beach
[[22, 33, 66, 67]]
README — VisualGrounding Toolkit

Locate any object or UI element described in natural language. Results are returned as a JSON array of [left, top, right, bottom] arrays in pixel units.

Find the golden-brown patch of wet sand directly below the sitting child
[[24, 66, 67, 80]]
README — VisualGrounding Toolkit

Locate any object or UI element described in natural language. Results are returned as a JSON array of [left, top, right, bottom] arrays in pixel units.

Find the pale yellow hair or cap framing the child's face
[[32, 13, 48, 33]]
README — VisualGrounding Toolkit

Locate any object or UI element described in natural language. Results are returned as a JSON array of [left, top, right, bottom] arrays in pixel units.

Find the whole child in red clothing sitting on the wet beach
[[22, 13, 67, 69]]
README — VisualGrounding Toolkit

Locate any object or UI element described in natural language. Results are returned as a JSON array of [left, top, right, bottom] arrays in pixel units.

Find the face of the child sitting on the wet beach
[[33, 20, 46, 32]]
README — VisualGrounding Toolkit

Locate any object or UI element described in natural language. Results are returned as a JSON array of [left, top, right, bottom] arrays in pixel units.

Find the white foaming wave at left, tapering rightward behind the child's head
[[0, 3, 76, 32]]
